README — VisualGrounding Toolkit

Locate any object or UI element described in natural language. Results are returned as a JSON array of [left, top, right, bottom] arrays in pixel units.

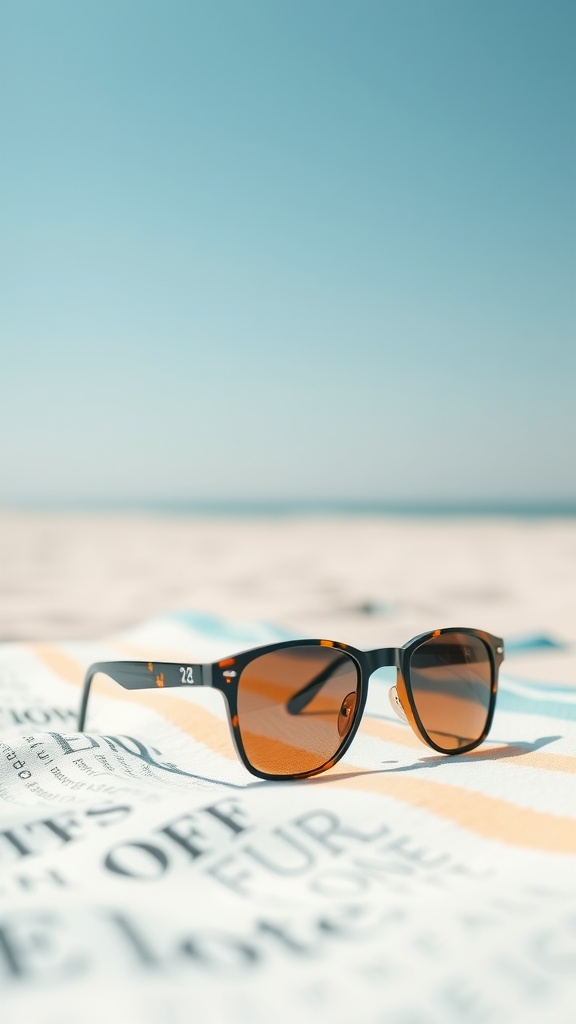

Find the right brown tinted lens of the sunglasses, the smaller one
[[410, 633, 492, 751]]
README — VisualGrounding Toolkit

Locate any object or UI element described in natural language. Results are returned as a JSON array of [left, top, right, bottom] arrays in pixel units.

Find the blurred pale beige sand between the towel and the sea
[[0, 513, 576, 685]]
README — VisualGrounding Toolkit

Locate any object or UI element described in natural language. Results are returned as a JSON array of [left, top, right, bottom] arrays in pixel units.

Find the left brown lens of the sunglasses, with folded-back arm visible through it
[[238, 645, 359, 775]]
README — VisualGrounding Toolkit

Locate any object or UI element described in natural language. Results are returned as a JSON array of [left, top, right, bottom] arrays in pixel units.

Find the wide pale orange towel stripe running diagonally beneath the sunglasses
[[25, 644, 576, 854]]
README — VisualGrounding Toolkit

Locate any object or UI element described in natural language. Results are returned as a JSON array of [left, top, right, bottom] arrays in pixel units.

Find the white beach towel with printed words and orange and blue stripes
[[0, 613, 576, 1024]]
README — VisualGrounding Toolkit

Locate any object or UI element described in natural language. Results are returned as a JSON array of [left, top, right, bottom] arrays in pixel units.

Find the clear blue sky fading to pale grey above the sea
[[0, 0, 576, 502]]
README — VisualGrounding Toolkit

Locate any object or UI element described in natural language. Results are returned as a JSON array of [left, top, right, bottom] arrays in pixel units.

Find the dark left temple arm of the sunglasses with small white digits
[[78, 662, 212, 732]]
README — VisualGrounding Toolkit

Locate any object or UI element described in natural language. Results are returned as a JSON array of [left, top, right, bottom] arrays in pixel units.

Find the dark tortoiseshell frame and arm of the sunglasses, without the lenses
[[78, 627, 504, 781]]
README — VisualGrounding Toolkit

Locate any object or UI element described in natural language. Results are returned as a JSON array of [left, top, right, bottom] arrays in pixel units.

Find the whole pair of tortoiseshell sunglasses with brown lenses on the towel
[[78, 629, 504, 779]]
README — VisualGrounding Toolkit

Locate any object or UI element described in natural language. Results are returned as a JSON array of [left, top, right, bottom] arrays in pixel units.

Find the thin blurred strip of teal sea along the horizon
[[5, 499, 576, 519]]
